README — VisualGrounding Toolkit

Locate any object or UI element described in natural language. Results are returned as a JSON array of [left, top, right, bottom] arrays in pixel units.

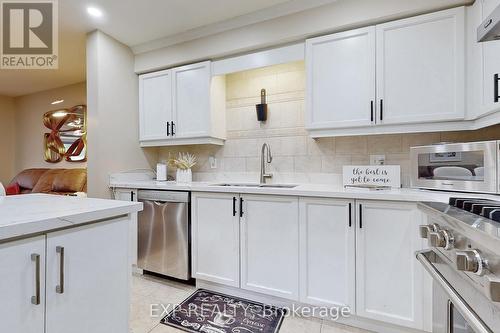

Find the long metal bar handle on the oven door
[[416, 250, 493, 333]]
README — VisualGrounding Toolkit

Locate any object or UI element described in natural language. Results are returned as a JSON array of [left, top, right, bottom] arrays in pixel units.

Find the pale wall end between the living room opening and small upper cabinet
[[87, 31, 157, 198]]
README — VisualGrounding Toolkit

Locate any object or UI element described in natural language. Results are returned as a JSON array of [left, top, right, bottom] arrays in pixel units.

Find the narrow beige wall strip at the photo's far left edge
[[0, 96, 15, 184]]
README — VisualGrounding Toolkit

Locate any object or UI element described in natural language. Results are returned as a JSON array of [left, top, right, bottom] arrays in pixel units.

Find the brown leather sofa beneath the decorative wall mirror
[[9, 168, 87, 195]]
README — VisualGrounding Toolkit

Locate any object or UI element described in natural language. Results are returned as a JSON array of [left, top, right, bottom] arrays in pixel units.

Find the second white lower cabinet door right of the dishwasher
[[241, 195, 299, 300]]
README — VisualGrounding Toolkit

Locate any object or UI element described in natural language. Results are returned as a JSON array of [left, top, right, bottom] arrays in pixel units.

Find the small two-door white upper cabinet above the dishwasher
[[139, 61, 226, 147]]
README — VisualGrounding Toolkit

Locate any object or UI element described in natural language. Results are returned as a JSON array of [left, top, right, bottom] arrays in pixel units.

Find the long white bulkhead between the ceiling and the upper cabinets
[[135, 0, 473, 73]]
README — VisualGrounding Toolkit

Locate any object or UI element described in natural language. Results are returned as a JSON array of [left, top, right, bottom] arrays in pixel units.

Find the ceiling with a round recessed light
[[0, 0, 336, 97]]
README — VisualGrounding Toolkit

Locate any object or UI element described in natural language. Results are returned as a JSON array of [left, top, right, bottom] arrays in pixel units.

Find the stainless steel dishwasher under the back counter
[[137, 190, 191, 280]]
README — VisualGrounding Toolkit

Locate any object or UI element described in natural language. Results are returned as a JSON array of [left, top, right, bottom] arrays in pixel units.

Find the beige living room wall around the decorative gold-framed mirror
[[14, 82, 87, 174]]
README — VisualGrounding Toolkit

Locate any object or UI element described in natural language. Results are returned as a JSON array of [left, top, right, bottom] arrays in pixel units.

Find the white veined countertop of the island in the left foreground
[[0, 194, 142, 242]]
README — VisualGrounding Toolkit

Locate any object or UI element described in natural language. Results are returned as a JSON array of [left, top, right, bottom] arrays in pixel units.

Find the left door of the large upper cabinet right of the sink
[[306, 27, 375, 129]]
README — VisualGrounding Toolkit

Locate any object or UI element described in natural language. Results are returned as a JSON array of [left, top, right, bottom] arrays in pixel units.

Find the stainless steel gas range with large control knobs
[[417, 198, 500, 333]]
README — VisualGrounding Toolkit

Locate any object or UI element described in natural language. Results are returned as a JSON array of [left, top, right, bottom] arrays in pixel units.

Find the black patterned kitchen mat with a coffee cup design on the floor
[[161, 289, 285, 333]]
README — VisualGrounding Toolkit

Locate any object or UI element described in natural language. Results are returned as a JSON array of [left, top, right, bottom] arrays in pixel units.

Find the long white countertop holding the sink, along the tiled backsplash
[[110, 180, 500, 202]]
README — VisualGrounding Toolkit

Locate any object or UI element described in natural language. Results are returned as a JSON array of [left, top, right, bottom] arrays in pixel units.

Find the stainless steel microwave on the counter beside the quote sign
[[410, 141, 500, 193]]
